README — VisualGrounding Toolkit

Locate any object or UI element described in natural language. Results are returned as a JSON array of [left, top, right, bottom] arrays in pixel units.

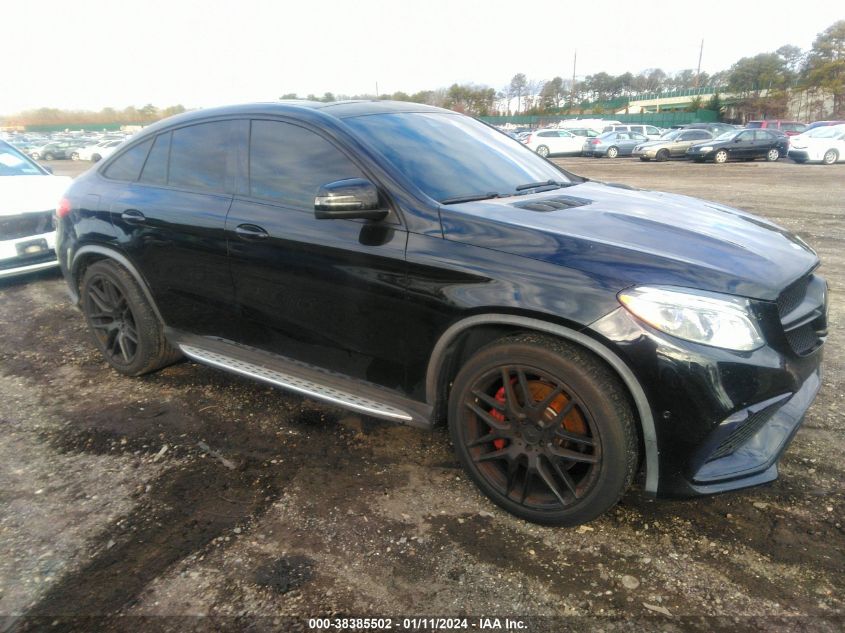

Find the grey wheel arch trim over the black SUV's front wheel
[[425, 314, 659, 495]]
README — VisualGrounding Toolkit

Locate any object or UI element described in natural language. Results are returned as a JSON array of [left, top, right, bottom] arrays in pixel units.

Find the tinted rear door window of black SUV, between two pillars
[[167, 121, 230, 191]]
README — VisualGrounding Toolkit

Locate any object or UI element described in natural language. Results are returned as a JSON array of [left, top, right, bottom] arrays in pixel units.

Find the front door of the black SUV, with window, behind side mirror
[[226, 119, 413, 387]]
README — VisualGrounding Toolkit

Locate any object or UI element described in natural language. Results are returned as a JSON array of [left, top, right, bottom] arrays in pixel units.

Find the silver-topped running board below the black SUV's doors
[[173, 332, 431, 428]]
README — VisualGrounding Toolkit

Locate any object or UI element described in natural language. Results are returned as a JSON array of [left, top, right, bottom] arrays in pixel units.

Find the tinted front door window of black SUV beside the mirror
[[249, 121, 364, 211]]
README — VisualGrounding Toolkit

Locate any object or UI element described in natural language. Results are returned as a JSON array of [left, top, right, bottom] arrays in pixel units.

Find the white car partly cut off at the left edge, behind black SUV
[[0, 141, 71, 277]]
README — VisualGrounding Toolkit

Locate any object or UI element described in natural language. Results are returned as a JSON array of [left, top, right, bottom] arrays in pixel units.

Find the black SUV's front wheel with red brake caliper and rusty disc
[[449, 334, 638, 525]]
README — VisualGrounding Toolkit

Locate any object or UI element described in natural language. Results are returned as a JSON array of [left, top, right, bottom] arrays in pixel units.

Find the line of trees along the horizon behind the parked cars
[[5, 20, 845, 125]]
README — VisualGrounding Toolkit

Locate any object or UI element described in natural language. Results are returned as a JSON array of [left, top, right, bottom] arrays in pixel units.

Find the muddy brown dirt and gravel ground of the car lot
[[0, 159, 845, 631]]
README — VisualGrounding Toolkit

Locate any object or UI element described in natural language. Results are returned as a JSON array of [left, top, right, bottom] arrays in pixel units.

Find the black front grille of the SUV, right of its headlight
[[777, 275, 827, 356]]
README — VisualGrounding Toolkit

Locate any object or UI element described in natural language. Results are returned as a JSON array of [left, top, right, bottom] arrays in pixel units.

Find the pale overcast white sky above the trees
[[0, 0, 845, 114]]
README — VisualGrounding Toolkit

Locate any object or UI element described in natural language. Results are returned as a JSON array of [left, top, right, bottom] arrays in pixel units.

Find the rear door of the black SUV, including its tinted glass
[[104, 120, 234, 336]]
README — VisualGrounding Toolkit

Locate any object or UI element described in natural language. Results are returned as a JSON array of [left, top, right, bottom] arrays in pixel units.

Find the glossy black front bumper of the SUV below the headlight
[[590, 280, 823, 497]]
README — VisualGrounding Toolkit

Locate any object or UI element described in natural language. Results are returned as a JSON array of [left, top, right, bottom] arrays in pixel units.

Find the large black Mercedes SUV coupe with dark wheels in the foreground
[[57, 101, 827, 525]]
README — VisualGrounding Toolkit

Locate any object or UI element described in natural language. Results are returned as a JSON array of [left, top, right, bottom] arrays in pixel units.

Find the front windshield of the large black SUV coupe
[[344, 112, 571, 202]]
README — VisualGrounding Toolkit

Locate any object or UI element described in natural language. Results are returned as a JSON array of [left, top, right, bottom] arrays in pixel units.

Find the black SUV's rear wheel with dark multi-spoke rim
[[80, 260, 180, 376]]
